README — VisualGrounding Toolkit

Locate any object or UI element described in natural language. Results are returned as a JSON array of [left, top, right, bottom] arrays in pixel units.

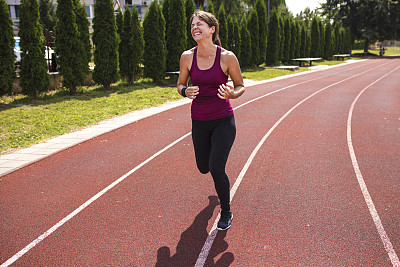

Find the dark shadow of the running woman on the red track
[[155, 196, 234, 267]]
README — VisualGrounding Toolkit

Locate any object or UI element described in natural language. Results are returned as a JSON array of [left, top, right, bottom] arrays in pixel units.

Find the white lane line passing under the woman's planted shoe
[[195, 59, 390, 267]]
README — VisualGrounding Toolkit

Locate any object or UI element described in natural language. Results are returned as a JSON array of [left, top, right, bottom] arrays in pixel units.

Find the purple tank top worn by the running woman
[[190, 46, 233, 121]]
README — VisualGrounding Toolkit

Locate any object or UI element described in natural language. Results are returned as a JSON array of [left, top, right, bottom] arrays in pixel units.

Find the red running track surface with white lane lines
[[0, 59, 400, 266]]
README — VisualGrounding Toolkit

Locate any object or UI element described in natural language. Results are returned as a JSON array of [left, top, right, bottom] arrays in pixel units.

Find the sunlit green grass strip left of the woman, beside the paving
[[0, 81, 181, 154]]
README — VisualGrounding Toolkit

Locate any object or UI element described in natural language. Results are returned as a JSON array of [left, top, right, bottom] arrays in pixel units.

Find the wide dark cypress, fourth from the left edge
[[92, 0, 119, 90]]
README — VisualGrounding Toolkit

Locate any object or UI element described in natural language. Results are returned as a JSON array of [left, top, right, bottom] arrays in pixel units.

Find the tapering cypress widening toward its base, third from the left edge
[[55, 0, 89, 95]]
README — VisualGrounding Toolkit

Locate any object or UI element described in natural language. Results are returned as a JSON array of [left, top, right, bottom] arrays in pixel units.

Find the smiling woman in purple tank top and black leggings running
[[177, 10, 245, 230]]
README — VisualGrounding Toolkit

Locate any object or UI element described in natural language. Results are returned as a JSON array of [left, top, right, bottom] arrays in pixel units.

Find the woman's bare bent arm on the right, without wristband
[[218, 52, 245, 99]]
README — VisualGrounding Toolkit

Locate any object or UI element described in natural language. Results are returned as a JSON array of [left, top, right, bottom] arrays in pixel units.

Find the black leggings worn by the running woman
[[192, 115, 236, 214]]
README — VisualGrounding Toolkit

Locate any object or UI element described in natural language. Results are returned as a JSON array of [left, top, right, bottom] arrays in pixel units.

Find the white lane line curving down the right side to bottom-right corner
[[347, 66, 400, 267]]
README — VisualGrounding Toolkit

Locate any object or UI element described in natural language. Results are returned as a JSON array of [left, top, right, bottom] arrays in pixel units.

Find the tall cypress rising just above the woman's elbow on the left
[[166, 0, 187, 71]]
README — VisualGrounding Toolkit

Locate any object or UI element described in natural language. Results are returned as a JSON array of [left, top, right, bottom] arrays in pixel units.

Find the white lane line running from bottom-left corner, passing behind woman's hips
[[0, 59, 382, 267]]
